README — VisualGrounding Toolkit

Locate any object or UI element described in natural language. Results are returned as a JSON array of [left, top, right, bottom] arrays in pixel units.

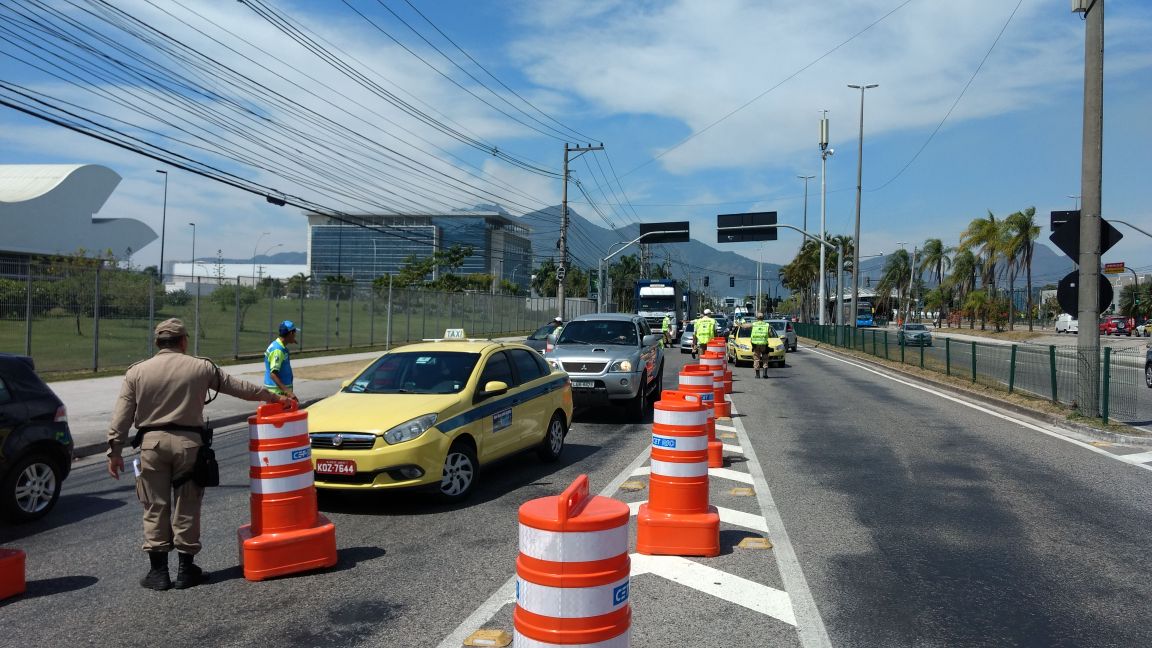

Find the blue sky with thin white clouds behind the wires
[[0, 0, 1152, 274]]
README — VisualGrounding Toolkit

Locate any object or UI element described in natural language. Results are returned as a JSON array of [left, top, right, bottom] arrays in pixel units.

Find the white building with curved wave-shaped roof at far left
[[0, 164, 157, 258]]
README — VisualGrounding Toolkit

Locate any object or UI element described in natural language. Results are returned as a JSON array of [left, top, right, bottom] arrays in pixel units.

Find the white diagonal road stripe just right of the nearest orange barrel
[[629, 553, 796, 626]]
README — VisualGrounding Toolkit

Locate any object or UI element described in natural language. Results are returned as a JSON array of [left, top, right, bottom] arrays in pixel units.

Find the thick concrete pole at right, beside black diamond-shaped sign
[[1074, 0, 1104, 417]]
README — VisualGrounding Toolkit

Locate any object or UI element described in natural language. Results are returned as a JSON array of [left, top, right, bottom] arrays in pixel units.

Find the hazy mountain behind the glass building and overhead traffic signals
[[516, 205, 780, 296]]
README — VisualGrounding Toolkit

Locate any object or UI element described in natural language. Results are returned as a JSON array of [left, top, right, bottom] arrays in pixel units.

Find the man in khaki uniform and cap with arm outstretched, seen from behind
[[108, 319, 288, 590]]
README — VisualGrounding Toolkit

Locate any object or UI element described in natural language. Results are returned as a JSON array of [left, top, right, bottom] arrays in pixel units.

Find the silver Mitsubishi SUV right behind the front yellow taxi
[[544, 312, 664, 421]]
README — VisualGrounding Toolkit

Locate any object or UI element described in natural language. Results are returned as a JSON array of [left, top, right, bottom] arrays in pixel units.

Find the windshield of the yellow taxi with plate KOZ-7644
[[341, 351, 480, 393]]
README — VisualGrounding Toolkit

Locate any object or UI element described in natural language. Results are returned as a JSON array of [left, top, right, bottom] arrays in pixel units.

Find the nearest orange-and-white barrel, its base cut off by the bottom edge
[[513, 475, 632, 648]]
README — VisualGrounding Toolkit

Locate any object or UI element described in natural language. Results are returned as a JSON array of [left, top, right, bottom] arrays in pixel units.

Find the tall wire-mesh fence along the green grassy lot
[[0, 255, 596, 372]]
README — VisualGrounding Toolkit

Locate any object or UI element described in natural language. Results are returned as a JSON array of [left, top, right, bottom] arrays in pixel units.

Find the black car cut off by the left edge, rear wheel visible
[[0, 353, 73, 522]]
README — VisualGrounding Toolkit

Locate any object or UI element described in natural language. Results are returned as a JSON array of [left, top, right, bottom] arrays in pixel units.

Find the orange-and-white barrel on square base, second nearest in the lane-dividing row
[[636, 400, 720, 556]]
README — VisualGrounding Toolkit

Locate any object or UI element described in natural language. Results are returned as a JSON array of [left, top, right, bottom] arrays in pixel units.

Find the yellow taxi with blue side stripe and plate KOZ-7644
[[308, 329, 573, 500]]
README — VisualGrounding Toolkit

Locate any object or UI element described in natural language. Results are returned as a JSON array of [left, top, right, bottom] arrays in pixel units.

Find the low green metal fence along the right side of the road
[[795, 324, 1152, 424]]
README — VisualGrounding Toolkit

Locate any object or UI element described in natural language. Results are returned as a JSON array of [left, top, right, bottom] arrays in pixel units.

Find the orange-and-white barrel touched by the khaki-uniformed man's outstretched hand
[[236, 402, 336, 580]]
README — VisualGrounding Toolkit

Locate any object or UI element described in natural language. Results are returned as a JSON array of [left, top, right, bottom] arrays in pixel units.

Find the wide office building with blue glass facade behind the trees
[[308, 212, 532, 289]]
